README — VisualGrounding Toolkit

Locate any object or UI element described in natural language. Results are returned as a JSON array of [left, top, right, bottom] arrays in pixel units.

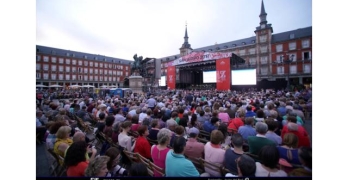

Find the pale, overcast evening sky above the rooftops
[[36, 0, 312, 60]]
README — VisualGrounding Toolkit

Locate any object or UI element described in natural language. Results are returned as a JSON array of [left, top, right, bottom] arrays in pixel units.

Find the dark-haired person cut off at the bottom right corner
[[289, 147, 312, 176]]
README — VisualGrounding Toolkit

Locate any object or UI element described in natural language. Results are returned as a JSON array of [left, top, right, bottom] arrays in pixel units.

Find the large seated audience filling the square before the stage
[[36, 89, 312, 177]]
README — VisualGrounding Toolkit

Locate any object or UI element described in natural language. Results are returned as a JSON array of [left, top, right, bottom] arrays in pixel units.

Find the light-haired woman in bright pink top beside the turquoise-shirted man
[[151, 128, 172, 177]]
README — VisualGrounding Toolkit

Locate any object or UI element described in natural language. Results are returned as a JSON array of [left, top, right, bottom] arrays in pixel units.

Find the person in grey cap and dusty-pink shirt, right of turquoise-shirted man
[[184, 127, 204, 158]]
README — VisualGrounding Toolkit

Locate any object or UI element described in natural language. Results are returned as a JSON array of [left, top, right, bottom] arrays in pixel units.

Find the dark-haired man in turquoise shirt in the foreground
[[165, 136, 198, 177]]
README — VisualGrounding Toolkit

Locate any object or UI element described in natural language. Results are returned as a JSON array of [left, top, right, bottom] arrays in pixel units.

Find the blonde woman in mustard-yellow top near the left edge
[[53, 126, 73, 164]]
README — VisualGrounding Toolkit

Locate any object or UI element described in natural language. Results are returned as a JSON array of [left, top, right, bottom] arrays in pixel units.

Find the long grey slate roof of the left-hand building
[[36, 45, 133, 64]]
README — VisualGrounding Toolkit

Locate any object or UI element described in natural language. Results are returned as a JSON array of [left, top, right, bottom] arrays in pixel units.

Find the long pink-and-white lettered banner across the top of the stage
[[167, 52, 232, 67]]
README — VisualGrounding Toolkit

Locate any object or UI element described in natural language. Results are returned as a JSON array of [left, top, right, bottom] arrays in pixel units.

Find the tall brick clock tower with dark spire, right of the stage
[[254, 0, 273, 80]]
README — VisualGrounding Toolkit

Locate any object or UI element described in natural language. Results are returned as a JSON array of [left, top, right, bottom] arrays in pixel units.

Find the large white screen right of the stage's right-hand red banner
[[231, 69, 256, 85]]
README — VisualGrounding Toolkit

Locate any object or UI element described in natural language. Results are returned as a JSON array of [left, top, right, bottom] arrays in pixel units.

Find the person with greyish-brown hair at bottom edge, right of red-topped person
[[85, 156, 110, 177]]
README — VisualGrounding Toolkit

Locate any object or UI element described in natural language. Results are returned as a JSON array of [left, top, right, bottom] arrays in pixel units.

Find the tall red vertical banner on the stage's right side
[[216, 58, 231, 91]]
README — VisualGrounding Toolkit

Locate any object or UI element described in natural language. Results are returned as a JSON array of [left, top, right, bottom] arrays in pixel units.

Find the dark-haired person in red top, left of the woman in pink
[[134, 125, 151, 159]]
